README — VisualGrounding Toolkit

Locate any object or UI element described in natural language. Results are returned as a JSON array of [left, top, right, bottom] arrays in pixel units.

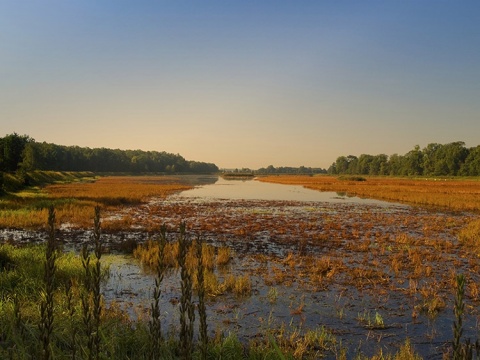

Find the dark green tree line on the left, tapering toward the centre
[[0, 133, 218, 173]]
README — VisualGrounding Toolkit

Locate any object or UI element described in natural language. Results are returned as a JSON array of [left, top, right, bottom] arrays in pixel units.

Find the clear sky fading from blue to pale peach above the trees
[[0, 0, 480, 169]]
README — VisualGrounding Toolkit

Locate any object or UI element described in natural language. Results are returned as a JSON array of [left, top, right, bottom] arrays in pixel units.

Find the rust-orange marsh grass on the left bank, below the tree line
[[0, 176, 191, 230]]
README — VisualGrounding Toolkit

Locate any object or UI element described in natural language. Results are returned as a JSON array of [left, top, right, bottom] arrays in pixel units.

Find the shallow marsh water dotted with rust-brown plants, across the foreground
[[4, 191, 480, 358]]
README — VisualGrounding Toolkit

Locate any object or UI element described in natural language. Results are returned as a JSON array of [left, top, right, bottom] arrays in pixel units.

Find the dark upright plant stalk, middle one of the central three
[[178, 222, 195, 360]]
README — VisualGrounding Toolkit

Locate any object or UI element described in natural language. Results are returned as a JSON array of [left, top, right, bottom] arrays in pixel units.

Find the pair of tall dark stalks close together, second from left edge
[[82, 206, 102, 359]]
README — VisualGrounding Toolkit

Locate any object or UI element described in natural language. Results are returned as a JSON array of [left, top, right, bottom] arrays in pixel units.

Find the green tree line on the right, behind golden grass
[[328, 141, 480, 176]]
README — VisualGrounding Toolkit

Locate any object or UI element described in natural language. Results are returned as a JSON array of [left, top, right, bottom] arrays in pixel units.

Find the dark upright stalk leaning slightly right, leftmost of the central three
[[149, 224, 167, 360]]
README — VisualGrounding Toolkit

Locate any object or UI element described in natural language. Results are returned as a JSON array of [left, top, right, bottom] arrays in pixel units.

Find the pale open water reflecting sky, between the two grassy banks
[[176, 177, 391, 205]]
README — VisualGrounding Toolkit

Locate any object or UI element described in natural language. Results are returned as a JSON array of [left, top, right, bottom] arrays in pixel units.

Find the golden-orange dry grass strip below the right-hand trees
[[259, 175, 480, 211]]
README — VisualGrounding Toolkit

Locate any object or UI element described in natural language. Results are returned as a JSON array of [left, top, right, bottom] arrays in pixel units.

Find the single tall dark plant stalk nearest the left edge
[[39, 206, 56, 360]]
